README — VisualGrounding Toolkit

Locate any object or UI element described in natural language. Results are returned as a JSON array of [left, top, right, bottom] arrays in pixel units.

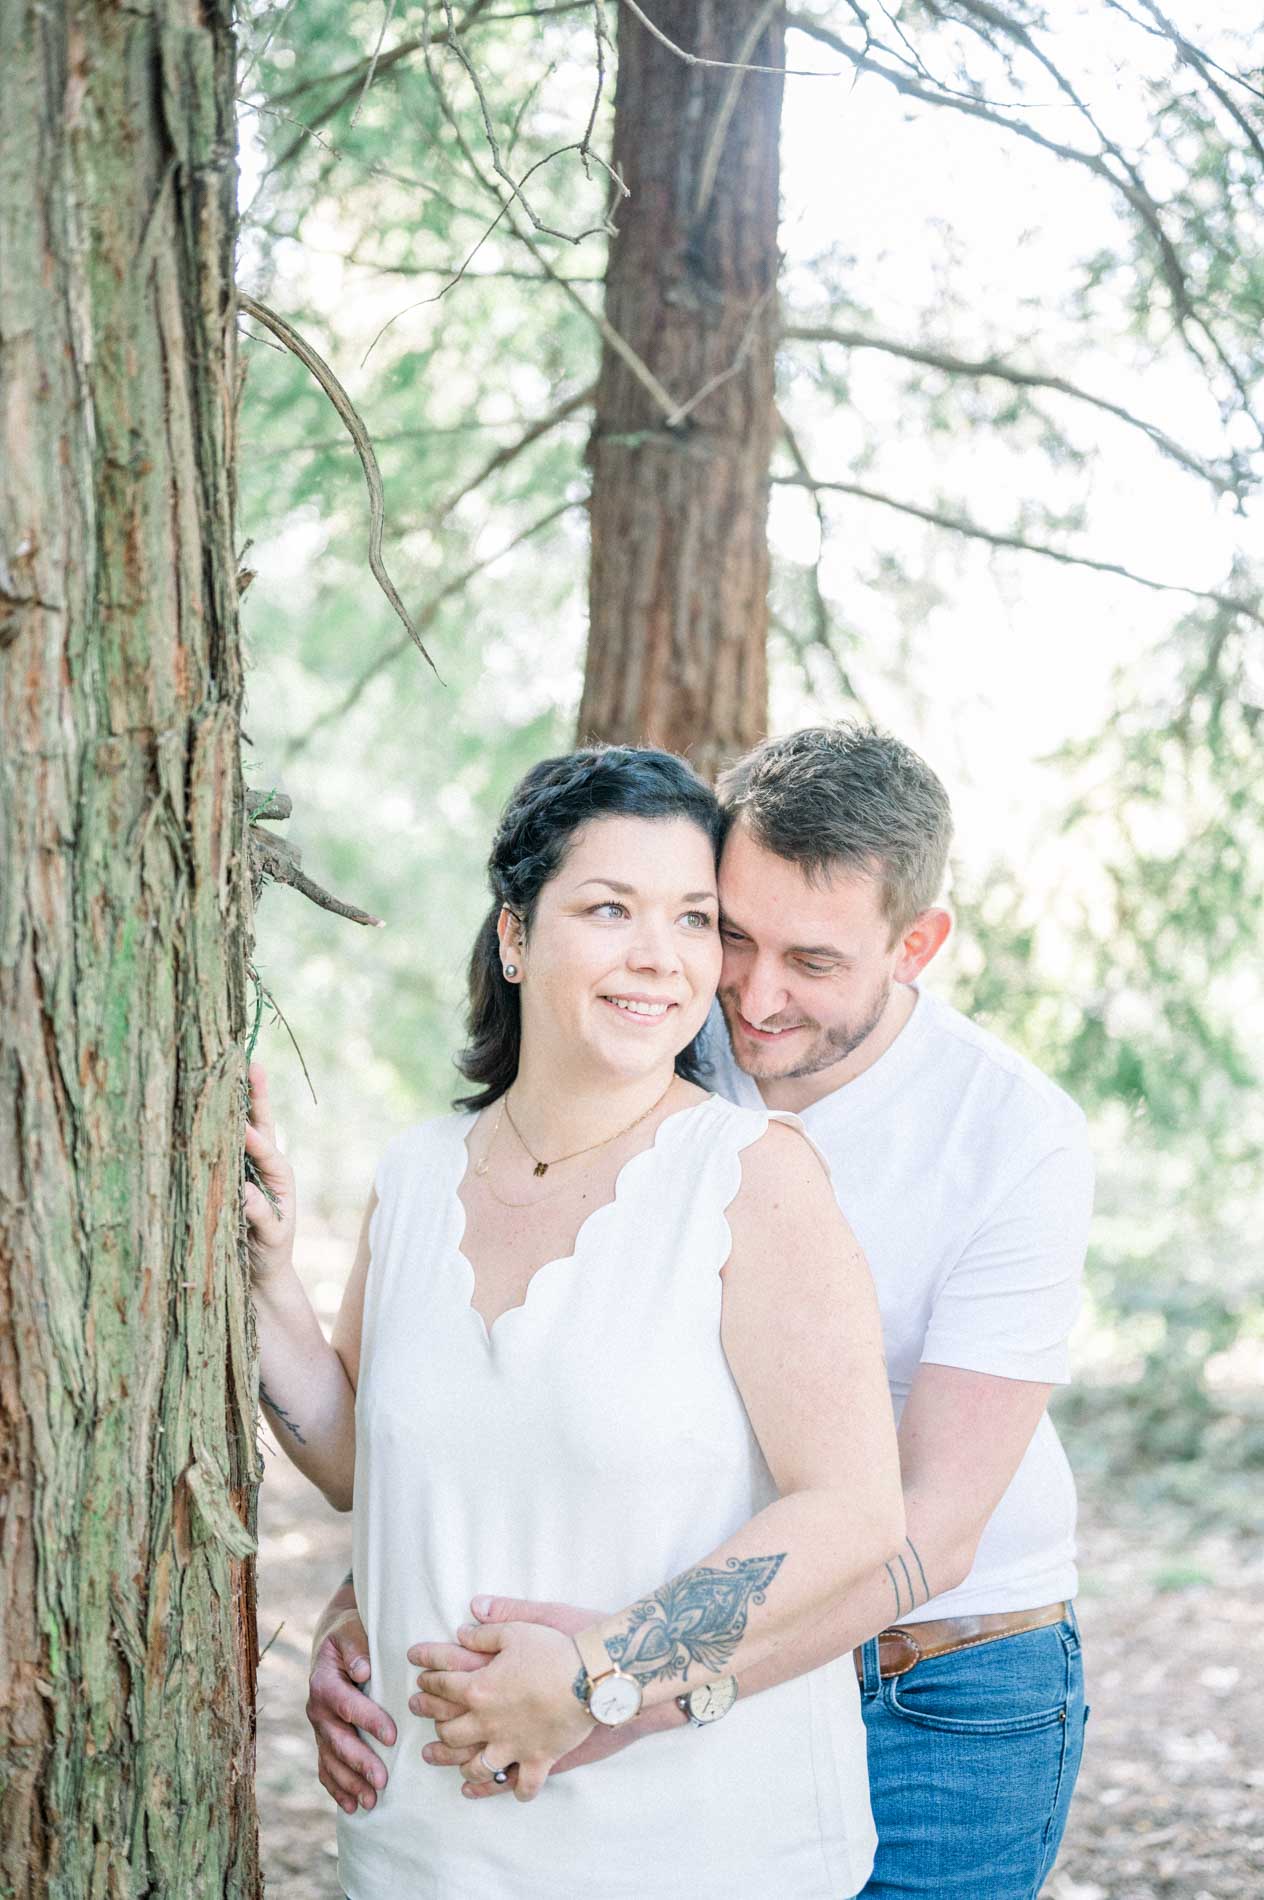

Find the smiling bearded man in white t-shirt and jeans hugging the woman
[[308, 726, 1091, 1900]]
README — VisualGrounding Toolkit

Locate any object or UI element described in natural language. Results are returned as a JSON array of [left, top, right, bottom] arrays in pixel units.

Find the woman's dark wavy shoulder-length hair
[[452, 745, 724, 1110]]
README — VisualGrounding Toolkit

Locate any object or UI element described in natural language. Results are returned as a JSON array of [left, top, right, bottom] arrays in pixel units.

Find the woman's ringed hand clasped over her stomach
[[409, 1623, 595, 1801]]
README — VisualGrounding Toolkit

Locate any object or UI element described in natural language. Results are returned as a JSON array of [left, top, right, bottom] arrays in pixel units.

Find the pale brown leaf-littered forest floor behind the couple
[[259, 1273, 1264, 1900]]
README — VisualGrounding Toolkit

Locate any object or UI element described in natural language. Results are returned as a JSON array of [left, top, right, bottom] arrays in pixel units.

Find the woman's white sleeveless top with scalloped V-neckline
[[338, 1094, 874, 1900]]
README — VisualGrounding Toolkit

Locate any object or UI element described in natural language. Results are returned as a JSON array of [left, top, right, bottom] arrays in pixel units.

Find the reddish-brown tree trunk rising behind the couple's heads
[[580, 0, 783, 773]]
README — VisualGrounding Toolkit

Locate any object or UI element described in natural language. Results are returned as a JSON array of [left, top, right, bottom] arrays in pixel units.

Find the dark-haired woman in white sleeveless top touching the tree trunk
[[247, 749, 903, 1900]]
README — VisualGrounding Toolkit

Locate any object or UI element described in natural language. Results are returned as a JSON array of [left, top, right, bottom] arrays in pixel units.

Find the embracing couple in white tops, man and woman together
[[247, 726, 1091, 1900]]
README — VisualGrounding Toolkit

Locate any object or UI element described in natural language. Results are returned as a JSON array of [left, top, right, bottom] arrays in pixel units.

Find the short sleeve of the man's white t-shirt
[[922, 1117, 1093, 1385]]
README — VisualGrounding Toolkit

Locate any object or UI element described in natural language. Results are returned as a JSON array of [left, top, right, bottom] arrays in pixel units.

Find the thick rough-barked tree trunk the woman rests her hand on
[[0, 0, 259, 1900]]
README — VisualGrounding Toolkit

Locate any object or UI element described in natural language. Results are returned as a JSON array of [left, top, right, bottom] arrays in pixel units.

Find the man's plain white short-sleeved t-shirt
[[705, 990, 1093, 1623]]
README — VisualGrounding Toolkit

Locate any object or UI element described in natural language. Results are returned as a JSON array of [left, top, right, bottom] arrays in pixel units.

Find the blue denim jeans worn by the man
[[861, 1609, 1089, 1900]]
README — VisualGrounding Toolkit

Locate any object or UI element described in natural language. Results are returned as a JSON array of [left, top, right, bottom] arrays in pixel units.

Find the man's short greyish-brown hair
[[717, 720, 952, 939]]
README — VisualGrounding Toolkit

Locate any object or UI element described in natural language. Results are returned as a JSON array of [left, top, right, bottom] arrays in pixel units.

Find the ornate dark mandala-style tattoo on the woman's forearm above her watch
[[606, 1550, 785, 1683]]
